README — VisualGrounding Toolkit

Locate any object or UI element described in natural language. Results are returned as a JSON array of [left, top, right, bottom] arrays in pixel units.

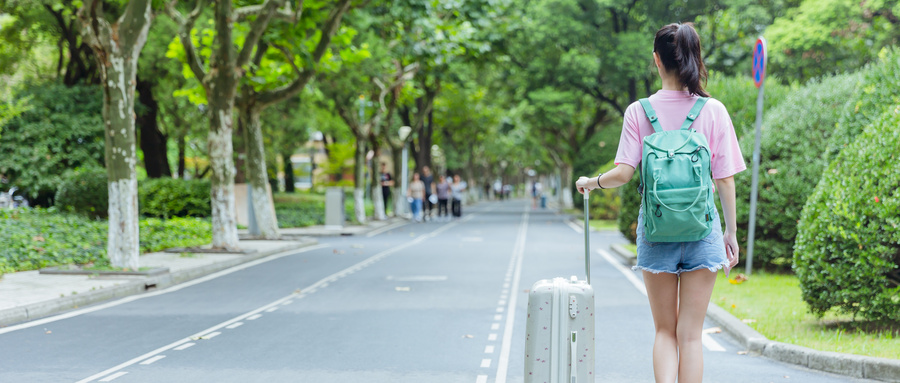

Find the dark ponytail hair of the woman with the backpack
[[653, 23, 709, 97]]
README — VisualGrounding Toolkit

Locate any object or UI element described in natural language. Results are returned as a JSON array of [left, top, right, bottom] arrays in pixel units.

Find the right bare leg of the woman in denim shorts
[[676, 269, 716, 383]]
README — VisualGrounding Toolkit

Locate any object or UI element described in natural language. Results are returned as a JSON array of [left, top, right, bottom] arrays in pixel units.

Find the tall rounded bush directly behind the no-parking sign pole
[[735, 74, 862, 270]]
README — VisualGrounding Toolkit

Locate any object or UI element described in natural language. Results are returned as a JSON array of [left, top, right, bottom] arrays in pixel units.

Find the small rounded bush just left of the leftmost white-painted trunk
[[55, 168, 109, 218]]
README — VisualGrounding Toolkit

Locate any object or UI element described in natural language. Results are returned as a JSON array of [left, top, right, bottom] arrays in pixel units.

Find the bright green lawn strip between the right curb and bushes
[[712, 270, 900, 359]]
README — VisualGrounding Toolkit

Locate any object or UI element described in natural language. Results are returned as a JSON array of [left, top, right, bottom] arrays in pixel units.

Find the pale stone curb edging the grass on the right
[[610, 245, 900, 383]]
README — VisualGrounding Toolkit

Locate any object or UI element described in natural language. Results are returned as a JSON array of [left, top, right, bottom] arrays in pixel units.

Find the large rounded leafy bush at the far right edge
[[793, 105, 900, 322]]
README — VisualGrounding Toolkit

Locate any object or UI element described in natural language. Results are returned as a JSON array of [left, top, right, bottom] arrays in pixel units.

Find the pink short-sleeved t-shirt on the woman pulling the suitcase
[[616, 90, 747, 180]]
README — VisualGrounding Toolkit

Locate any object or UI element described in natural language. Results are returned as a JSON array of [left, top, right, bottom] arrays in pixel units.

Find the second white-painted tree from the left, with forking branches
[[167, 0, 302, 250]]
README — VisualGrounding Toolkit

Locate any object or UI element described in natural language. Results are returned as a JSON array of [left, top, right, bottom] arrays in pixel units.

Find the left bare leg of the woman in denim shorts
[[644, 271, 679, 383]]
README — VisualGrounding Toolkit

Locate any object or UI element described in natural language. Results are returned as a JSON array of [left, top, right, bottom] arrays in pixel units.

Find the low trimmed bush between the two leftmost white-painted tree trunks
[[138, 177, 212, 219]]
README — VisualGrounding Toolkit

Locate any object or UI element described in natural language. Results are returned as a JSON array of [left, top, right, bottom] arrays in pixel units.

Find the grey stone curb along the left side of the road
[[0, 240, 318, 327]]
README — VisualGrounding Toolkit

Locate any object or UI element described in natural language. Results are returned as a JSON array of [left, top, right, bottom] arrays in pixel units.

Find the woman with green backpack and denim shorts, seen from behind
[[575, 24, 746, 383]]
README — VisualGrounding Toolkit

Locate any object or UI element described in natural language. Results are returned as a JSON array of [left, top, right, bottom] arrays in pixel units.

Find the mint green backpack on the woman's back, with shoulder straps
[[640, 97, 716, 242]]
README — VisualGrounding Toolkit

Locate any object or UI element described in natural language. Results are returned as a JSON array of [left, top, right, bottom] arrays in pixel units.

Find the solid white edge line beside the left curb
[[0, 244, 328, 334]]
